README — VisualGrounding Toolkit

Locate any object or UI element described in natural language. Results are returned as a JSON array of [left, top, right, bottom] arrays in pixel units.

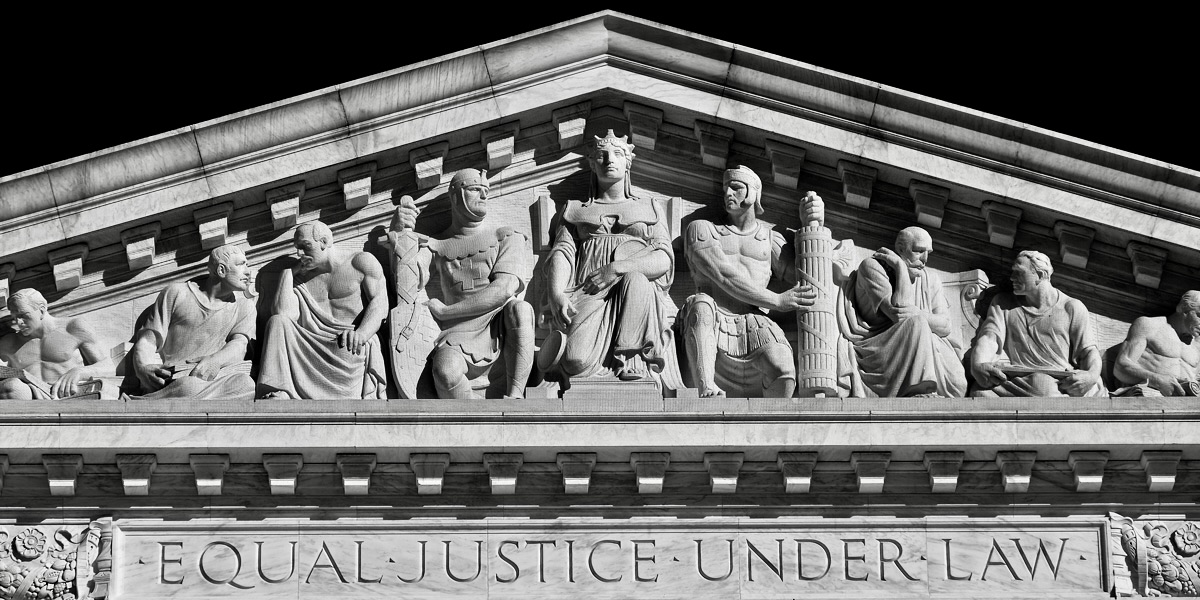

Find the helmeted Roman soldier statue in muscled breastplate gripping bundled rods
[[680, 166, 824, 398]]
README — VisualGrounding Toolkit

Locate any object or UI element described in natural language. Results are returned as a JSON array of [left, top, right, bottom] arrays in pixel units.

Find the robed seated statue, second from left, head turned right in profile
[[132, 245, 258, 400]]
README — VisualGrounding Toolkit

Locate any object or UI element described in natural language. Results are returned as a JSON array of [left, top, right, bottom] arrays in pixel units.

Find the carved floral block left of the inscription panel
[[0, 526, 103, 600]]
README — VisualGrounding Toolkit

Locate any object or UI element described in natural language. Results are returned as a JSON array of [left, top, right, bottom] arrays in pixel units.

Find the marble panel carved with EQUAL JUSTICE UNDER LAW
[[114, 520, 1108, 598]]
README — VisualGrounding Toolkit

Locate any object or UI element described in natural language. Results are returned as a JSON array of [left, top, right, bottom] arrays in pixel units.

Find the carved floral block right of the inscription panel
[[1109, 512, 1200, 596]]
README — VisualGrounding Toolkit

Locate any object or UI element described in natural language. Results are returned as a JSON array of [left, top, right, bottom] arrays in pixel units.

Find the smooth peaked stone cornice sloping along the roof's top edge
[[0, 11, 1200, 276]]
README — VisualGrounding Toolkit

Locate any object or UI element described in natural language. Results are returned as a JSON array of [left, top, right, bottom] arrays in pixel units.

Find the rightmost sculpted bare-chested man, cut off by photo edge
[[1112, 289, 1200, 396]]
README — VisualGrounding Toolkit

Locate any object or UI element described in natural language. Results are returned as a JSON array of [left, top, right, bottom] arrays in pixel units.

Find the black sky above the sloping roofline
[[0, 8, 1200, 175]]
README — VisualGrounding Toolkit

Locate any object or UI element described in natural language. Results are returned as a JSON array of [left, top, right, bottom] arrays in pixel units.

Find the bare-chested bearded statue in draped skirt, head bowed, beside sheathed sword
[[258, 222, 388, 400]]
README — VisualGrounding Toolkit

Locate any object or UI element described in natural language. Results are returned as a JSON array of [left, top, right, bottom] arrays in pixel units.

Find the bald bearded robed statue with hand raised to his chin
[[852, 227, 967, 397]]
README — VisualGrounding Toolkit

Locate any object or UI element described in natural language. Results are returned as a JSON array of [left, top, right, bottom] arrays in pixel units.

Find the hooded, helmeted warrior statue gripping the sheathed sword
[[390, 169, 534, 398]]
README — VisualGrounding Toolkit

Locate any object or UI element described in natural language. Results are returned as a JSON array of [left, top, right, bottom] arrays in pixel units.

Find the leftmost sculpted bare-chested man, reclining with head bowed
[[0, 288, 112, 400]]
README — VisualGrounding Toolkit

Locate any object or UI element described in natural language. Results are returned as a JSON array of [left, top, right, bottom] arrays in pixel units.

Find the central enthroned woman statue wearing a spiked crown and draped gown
[[540, 130, 682, 389]]
